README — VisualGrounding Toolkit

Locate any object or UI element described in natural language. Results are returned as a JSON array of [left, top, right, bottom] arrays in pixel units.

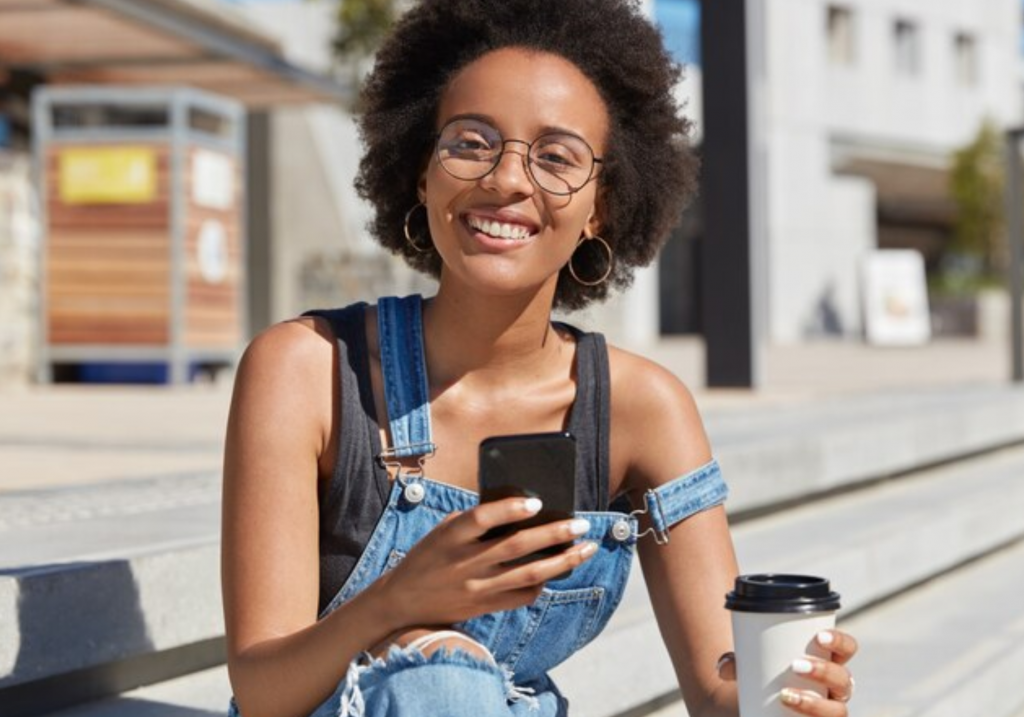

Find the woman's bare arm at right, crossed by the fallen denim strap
[[611, 351, 737, 717]]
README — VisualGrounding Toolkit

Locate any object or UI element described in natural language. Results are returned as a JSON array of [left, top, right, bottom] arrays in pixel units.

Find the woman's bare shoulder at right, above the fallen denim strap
[[608, 346, 711, 489]]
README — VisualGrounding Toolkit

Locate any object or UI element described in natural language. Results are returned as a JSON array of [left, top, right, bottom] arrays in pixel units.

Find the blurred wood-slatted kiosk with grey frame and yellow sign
[[33, 86, 246, 383]]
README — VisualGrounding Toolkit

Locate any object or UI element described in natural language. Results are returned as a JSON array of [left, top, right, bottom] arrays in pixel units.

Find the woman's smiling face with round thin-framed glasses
[[419, 48, 609, 296]]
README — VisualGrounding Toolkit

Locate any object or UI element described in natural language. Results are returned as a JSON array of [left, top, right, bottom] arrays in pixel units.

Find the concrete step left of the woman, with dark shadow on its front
[[0, 472, 224, 715]]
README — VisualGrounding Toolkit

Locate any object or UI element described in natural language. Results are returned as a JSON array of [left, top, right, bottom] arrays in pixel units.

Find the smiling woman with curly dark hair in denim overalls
[[223, 0, 856, 717]]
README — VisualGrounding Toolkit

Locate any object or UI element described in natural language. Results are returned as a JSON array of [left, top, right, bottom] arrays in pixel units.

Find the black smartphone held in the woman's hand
[[478, 431, 575, 565]]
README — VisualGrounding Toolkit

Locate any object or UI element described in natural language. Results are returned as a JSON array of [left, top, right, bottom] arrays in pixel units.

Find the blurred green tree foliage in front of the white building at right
[[949, 122, 1006, 278]]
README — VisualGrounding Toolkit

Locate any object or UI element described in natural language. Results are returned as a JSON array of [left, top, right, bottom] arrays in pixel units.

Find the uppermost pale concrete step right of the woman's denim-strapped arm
[[705, 384, 1024, 514]]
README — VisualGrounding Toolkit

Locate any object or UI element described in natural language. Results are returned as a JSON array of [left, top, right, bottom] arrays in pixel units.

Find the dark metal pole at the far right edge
[[1006, 132, 1024, 383]]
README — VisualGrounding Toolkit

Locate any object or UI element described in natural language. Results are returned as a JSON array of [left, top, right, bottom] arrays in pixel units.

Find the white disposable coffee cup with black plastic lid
[[725, 574, 840, 717]]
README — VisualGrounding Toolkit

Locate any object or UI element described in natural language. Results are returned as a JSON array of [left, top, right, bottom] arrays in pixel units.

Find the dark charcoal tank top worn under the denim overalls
[[306, 302, 610, 611]]
